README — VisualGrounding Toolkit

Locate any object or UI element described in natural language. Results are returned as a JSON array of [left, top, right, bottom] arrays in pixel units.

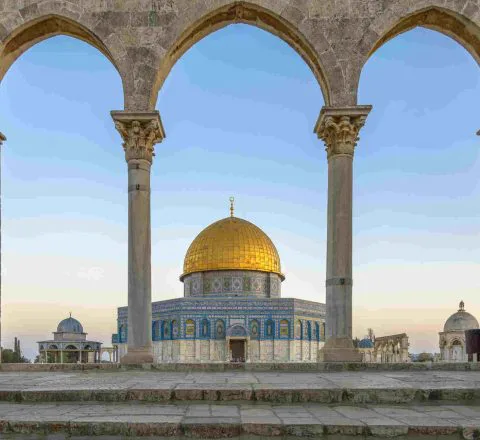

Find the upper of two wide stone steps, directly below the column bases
[[0, 371, 480, 404]]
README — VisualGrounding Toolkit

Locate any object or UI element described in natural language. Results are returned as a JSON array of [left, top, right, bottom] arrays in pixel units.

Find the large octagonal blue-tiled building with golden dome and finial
[[112, 199, 325, 362]]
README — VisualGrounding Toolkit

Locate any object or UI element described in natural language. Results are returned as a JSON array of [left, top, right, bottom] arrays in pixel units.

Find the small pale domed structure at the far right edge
[[439, 301, 479, 362]]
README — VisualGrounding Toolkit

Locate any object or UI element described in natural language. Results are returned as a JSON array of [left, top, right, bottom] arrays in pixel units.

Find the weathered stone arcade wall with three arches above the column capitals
[[0, 0, 480, 111]]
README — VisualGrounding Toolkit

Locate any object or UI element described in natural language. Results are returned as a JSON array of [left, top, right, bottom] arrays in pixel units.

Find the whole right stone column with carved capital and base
[[315, 106, 372, 362]]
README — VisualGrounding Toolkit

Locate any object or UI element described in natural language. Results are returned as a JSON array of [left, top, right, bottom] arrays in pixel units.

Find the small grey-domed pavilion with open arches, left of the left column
[[38, 313, 102, 363]]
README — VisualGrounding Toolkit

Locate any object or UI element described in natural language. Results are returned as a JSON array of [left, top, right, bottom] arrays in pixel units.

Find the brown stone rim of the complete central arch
[[149, 1, 332, 109]]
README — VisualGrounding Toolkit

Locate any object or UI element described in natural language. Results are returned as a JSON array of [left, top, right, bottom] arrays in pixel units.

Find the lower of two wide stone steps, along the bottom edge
[[0, 402, 480, 440]]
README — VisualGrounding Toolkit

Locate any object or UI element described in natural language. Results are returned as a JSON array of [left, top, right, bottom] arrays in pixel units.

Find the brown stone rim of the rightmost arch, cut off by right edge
[[355, 6, 480, 98]]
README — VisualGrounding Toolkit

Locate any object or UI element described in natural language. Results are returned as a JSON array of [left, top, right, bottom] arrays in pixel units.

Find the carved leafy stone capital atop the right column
[[314, 105, 372, 159]]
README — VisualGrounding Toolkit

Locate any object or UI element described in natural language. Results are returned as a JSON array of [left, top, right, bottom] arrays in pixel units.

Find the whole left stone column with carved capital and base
[[112, 111, 165, 364]]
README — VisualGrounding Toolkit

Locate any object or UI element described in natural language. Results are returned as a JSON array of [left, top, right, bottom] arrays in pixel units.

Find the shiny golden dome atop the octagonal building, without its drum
[[180, 217, 284, 280]]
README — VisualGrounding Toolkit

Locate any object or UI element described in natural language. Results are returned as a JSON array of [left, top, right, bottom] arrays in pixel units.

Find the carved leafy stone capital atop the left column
[[110, 111, 165, 163]]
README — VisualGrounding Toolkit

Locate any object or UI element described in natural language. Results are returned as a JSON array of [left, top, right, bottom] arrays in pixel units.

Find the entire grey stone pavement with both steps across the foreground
[[0, 370, 480, 440]]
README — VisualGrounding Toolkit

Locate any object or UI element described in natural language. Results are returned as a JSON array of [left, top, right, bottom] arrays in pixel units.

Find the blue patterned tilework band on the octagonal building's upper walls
[[114, 296, 325, 348]]
